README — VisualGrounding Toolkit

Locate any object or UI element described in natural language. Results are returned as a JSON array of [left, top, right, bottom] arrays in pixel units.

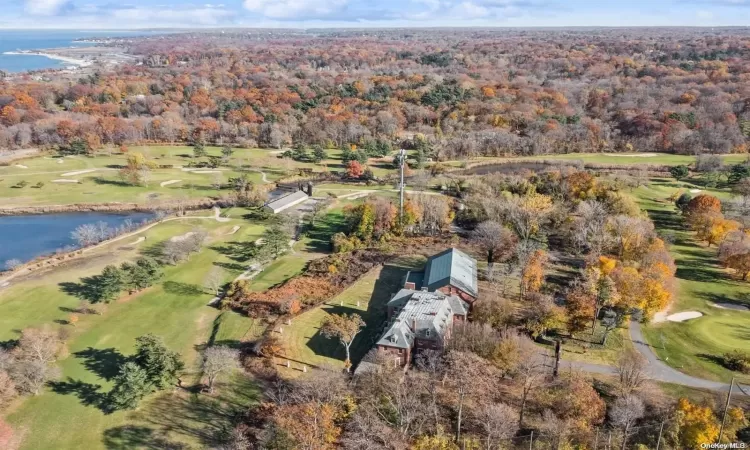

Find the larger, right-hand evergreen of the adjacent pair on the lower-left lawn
[[133, 334, 184, 389]]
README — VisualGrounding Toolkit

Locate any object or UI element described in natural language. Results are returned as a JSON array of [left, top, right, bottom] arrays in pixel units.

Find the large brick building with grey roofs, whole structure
[[375, 248, 478, 366]]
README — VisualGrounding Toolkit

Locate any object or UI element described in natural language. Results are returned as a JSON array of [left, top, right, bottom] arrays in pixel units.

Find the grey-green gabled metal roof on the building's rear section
[[424, 248, 479, 297]]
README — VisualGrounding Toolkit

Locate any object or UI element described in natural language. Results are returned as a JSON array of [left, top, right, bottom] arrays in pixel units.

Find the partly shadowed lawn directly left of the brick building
[[277, 257, 424, 377]]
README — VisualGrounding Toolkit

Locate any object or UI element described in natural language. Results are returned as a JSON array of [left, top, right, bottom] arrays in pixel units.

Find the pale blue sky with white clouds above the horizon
[[0, 0, 750, 29]]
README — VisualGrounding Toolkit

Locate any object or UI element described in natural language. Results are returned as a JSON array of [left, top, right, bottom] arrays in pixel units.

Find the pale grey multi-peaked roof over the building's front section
[[377, 289, 469, 348]]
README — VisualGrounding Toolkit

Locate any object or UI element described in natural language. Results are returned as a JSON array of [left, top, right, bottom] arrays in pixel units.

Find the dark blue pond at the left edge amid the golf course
[[0, 212, 153, 271]]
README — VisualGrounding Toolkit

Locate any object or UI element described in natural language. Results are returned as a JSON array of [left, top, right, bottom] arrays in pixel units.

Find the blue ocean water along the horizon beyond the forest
[[0, 30, 157, 72]]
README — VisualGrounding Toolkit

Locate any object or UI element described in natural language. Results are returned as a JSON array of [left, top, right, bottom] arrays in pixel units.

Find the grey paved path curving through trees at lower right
[[561, 321, 750, 391]]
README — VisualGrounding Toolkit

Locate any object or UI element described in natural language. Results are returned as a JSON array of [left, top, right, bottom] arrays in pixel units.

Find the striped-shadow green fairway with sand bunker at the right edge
[[635, 180, 750, 381]]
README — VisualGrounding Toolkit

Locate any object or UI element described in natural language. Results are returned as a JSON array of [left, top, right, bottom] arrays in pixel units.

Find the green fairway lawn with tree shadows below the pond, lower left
[[0, 213, 263, 449]]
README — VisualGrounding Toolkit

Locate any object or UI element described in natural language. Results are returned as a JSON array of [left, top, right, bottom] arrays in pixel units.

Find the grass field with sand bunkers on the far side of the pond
[[0, 145, 400, 206]]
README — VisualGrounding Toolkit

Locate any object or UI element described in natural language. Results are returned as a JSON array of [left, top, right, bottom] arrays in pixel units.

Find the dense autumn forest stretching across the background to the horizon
[[0, 29, 750, 160]]
